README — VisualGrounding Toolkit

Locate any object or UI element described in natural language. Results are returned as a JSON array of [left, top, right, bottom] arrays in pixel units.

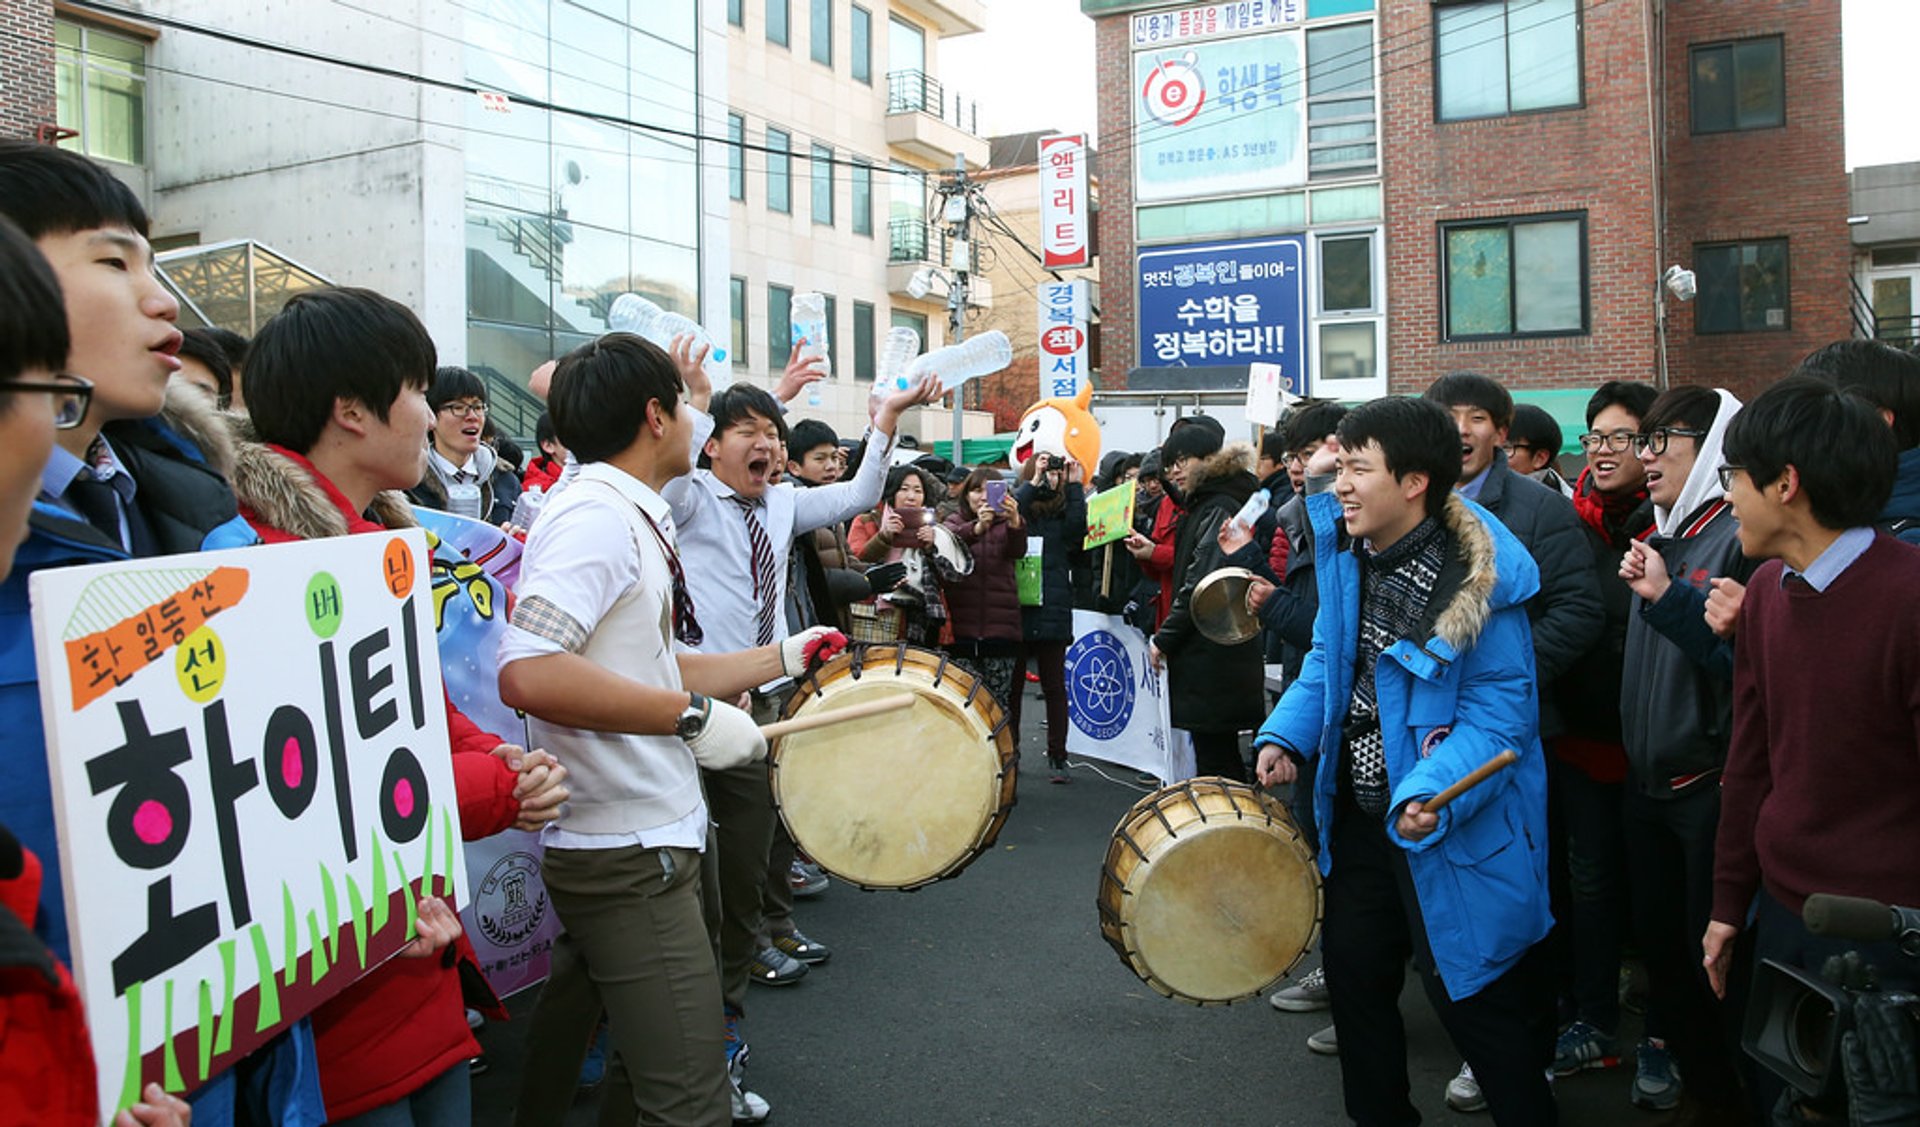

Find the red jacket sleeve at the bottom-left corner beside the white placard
[[0, 827, 100, 1127]]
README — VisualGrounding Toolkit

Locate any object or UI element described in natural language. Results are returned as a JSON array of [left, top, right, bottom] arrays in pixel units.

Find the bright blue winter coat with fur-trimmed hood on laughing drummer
[[1256, 490, 1553, 1000]]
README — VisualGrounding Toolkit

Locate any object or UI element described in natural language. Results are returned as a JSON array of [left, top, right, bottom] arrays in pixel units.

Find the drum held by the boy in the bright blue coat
[[1098, 778, 1321, 1006]]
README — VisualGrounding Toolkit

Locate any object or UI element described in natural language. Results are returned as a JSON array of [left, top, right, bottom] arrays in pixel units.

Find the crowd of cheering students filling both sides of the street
[[0, 142, 1920, 1127]]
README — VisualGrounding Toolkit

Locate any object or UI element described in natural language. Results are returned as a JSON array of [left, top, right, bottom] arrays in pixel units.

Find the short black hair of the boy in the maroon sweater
[[1724, 376, 1899, 532]]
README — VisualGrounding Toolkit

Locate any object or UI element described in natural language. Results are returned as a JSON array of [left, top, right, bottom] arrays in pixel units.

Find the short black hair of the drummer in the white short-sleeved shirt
[[547, 332, 680, 465]]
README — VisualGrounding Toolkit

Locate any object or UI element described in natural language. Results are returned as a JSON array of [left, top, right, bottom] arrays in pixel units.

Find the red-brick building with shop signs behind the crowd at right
[[1081, 0, 1853, 399]]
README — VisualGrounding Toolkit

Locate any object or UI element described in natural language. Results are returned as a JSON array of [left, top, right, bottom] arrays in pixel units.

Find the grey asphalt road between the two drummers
[[474, 705, 1667, 1127]]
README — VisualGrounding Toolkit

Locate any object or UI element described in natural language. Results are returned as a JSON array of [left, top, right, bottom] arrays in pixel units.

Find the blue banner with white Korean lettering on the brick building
[[1135, 234, 1308, 396]]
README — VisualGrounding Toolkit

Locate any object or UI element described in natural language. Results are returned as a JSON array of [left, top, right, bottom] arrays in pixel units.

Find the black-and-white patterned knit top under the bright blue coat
[[1346, 516, 1448, 814]]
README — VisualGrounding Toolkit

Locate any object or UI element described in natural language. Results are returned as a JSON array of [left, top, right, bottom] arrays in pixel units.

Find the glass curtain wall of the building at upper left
[[461, 0, 701, 415]]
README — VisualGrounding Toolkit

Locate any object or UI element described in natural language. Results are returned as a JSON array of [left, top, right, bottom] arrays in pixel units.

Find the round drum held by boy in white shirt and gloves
[[770, 643, 1018, 889]]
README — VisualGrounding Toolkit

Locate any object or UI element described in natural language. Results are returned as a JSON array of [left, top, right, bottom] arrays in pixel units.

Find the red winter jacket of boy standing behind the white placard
[[240, 447, 520, 1119]]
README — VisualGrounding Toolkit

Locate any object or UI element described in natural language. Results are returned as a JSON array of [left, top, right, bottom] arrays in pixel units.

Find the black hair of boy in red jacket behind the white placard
[[246, 286, 438, 453]]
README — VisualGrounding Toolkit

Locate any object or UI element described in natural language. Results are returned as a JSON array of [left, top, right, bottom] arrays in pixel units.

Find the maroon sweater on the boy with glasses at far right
[[1713, 536, 1920, 927]]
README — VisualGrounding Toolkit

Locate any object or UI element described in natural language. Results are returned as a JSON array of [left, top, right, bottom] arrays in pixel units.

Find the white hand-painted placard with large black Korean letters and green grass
[[31, 530, 467, 1115]]
